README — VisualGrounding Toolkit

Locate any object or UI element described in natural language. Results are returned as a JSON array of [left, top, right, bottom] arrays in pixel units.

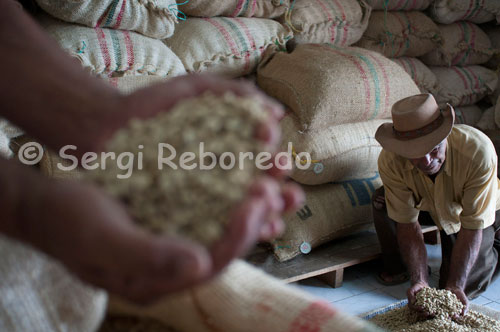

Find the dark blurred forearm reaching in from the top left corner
[[0, 0, 119, 150]]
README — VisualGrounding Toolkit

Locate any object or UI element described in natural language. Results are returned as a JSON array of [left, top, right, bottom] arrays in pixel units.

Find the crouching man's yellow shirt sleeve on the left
[[378, 151, 419, 223]]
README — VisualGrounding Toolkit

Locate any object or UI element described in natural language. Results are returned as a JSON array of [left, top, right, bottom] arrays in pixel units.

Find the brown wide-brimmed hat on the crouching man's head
[[375, 93, 455, 158]]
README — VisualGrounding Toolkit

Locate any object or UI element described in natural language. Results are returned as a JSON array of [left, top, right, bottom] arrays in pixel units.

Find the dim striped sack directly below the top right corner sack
[[420, 21, 494, 66]]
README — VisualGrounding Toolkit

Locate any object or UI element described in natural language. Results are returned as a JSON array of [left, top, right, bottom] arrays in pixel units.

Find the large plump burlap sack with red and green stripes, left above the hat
[[257, 44, 420, 130]]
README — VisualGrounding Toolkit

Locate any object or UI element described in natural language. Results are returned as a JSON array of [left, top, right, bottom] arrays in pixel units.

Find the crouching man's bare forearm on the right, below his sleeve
[[446, 228, 483, 290]]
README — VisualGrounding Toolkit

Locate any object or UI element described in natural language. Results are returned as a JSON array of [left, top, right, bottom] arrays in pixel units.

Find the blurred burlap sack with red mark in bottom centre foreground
[[109, 261, 379, 332]]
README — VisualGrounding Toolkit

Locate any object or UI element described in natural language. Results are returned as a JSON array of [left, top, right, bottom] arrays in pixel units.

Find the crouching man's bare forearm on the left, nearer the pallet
[[397, 222, 427, 285]]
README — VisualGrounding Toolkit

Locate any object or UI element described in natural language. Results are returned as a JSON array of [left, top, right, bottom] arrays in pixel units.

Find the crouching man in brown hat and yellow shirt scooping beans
[[373, 94, 500, 313]]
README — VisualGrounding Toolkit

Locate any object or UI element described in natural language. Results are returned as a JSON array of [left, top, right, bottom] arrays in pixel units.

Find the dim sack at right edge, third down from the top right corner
[[429, 66, 498, 107]]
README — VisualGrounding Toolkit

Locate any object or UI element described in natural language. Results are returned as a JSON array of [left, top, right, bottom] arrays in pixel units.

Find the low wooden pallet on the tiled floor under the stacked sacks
[[247, 226, 439, 288]]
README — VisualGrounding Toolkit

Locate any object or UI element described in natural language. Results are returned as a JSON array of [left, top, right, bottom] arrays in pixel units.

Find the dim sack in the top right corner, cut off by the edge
[[430, 0, 500, 24]]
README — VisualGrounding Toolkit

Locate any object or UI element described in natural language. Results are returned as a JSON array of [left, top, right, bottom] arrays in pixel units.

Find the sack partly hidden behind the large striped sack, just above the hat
[[391, 57, 440, 95]]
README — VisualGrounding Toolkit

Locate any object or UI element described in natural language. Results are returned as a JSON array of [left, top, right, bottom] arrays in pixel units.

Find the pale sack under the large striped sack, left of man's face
[[280, 115, 387, 185]]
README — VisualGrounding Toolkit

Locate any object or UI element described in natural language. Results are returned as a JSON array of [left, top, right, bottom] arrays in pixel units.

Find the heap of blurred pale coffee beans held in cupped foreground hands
[[87, 94, 271, 246]]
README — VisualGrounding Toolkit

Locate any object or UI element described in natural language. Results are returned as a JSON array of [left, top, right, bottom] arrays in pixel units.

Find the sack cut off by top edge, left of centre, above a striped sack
[[179, 0, 290, 18]]
